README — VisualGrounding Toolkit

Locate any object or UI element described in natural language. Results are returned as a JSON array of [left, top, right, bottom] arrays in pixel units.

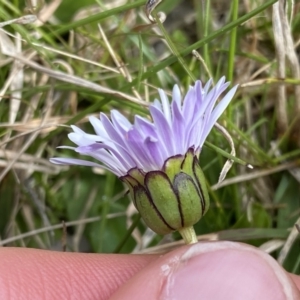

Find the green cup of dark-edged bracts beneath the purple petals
[[121, 148, 209, 234]]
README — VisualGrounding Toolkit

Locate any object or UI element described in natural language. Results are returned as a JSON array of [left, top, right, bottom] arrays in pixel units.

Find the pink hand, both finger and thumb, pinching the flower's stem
[[0, 242, 300, 300]]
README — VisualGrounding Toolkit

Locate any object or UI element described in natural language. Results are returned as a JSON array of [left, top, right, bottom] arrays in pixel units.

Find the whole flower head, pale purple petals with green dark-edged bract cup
[[51, 77, 237, 241]]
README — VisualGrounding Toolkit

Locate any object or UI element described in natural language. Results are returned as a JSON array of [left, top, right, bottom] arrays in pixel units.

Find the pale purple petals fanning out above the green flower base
[[50, 77, 237, 177]]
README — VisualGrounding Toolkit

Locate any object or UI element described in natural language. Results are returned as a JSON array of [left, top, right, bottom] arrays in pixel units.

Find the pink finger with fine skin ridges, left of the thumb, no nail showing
[[0, 248, 156, 300]]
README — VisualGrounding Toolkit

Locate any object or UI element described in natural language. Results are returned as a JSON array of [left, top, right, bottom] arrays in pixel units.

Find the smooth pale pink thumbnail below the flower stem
[[161, 242, 298, 300]]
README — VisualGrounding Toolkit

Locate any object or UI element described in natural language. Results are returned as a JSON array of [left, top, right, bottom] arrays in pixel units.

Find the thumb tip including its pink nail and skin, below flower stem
[[112, 242, 299, 300]]
